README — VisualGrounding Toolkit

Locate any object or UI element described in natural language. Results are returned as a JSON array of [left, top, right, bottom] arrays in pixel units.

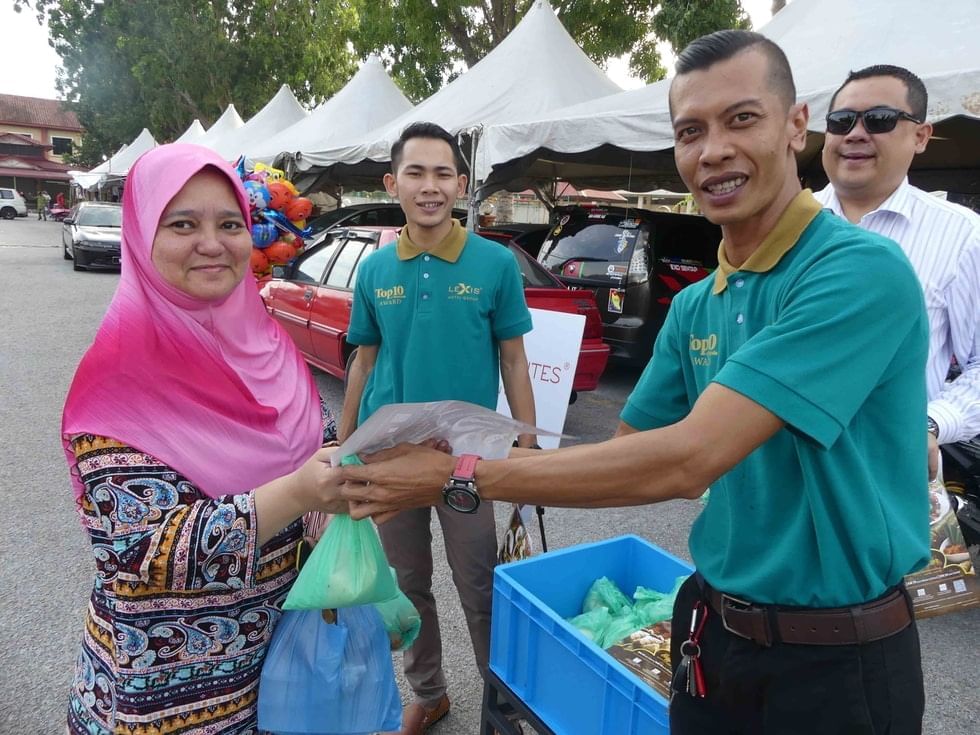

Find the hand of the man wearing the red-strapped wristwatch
[[341, 441, 456, 523]]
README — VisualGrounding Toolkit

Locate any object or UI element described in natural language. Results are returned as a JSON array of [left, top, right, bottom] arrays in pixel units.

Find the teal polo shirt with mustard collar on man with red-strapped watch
[[622, 190, 929, 607]]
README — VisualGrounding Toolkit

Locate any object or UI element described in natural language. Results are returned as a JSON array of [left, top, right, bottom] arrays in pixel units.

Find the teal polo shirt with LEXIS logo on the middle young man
[[347, 220, 532, 423]]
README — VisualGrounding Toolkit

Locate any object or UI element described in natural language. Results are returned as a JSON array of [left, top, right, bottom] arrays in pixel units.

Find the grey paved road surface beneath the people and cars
[[0, 220, 980, 735]]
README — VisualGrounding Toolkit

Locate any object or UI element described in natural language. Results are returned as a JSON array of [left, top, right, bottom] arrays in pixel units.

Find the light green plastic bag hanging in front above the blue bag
[[282, 456, 398, 610]]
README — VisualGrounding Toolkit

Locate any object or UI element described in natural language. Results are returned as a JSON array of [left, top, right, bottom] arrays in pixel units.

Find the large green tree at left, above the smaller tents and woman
[[20, 0, 358, 165]]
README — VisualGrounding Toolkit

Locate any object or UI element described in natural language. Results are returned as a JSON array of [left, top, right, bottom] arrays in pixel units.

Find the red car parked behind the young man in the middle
[[260, 227, 609, 400]]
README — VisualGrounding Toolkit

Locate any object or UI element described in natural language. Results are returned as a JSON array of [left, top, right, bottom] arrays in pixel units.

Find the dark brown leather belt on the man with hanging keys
[[698, 575, 912, 647]]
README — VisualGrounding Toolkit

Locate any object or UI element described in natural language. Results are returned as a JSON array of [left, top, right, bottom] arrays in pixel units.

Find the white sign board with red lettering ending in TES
[[497, 309, 585, 449]]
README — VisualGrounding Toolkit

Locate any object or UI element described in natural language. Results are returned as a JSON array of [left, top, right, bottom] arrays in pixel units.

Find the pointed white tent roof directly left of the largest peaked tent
[[251, 54, 412, 163]]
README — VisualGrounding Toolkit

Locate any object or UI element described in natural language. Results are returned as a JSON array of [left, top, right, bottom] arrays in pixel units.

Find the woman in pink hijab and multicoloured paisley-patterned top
[[62, 144, 347, 735]]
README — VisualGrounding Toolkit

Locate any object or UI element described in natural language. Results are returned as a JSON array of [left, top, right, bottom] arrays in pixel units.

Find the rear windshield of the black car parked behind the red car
[[539, 210, 646, 283]]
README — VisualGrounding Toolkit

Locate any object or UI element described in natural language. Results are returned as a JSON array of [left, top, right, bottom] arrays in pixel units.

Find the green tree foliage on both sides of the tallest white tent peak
[[352, 0, 749, 100]]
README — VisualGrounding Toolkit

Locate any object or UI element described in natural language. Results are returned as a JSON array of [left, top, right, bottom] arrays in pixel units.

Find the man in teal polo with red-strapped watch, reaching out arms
[[345, 31, 929, 735]]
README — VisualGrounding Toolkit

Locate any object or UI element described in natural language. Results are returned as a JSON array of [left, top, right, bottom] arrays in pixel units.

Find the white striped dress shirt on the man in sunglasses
[[816, 179, 980, 444]]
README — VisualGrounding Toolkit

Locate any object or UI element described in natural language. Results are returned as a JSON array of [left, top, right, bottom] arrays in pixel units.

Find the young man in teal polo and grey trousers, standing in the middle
[[339, 123, 535, 735]]
